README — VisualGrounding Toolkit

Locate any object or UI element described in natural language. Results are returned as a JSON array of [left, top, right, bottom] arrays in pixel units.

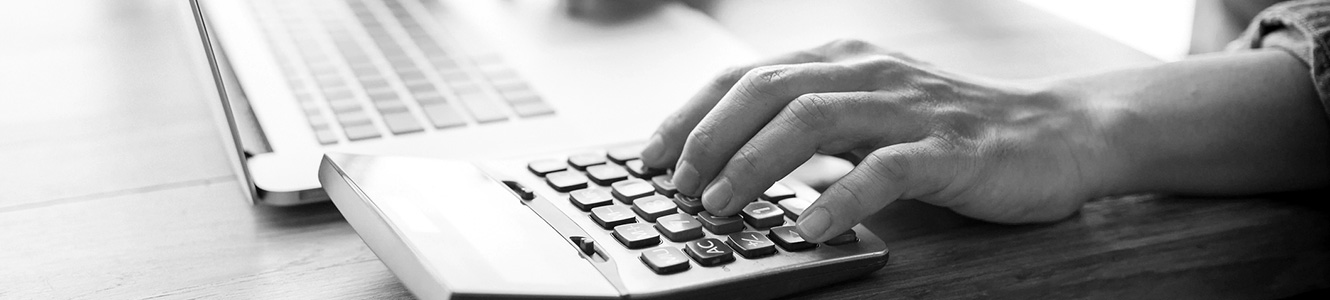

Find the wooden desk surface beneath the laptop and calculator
[[0, 0, 1330, 299]]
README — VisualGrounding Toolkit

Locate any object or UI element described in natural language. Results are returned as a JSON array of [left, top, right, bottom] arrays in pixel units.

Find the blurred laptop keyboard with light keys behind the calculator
[[251, 0, 555, 145]]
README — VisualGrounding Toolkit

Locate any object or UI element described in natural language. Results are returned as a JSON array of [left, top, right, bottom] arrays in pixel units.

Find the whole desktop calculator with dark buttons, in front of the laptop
[[319, 145, 888, 299]]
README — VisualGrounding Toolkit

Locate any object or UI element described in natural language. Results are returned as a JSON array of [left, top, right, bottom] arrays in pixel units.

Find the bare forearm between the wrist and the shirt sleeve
[[1051, 50, 1330, 195]]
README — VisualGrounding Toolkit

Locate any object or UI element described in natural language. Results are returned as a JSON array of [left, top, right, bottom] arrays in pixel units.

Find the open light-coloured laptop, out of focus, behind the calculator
[[192, 0, 753, 206]]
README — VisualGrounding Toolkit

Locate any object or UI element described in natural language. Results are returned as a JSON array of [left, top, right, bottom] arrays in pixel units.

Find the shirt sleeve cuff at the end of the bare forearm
[[1228, 0, 1330, 114]]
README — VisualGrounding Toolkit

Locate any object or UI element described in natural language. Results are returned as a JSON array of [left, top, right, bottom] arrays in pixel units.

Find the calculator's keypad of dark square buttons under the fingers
[[527, 149, 859, 275]]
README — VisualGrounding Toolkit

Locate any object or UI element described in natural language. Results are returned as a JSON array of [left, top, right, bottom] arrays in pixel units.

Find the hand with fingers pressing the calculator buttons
[[642, 41, 1120, 242]]
